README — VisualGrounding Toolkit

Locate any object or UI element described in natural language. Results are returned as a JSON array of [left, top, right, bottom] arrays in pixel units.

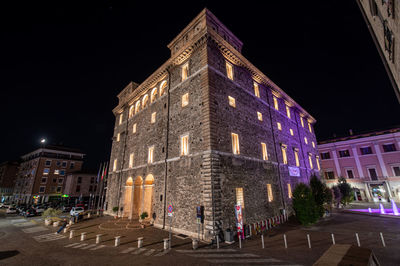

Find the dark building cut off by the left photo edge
[[0, 162, 19, 202]]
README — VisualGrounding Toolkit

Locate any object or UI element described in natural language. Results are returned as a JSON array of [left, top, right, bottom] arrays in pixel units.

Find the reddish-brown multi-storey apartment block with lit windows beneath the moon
[[14, 145, 85, 203]]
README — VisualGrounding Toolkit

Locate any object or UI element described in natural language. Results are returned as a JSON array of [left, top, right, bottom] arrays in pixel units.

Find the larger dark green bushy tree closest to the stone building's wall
[[292, 183, 319, 225]]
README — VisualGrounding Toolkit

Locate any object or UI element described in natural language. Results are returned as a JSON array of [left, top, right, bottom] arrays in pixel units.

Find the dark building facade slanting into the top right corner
[[356, 0, 400, 102]]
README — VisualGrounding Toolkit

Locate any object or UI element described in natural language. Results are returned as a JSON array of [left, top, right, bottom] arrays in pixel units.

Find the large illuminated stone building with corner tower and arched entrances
[[107, 9, 319, 239]]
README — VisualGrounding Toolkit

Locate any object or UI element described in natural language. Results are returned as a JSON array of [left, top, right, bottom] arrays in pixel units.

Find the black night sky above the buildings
[[0, 0, 400, 169]]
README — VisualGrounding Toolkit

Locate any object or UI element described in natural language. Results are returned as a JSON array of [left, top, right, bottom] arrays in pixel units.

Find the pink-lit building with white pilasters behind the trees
[[318, 128, 400, 202]]
